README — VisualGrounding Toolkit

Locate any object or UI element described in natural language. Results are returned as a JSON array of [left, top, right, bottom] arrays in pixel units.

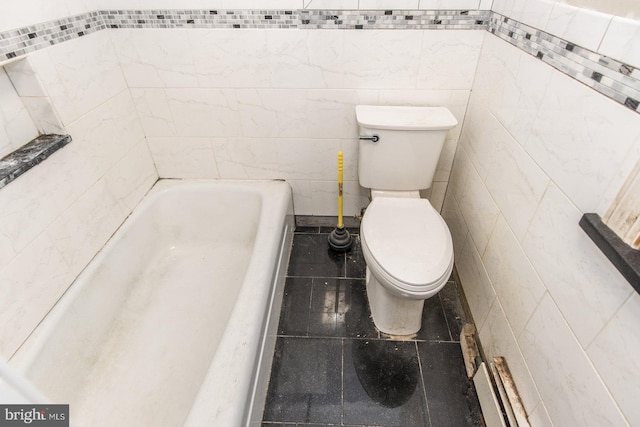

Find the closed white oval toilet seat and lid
[[360, 197, 453, 299]]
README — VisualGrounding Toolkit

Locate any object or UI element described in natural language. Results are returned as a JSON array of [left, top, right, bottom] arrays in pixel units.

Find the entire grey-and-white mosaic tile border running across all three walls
[[0, 10, 640, 113]]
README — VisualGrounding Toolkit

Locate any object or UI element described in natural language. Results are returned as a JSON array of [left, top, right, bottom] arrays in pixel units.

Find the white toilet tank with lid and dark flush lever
[[356, 105, 458, 191]]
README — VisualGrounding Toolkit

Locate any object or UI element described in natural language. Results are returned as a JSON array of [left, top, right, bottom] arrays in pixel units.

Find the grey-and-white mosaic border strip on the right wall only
[[489, 13, 640, 113]]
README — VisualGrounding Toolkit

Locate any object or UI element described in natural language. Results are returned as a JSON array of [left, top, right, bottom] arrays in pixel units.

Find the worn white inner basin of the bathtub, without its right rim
[[11, 180, 292, 426]]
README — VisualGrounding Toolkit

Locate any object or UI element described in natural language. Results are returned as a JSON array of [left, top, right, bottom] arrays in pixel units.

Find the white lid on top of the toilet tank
[[356, 105, 458, 130]]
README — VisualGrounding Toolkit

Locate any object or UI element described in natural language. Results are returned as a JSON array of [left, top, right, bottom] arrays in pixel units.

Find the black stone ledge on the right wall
[[579, 213, 640, 293]]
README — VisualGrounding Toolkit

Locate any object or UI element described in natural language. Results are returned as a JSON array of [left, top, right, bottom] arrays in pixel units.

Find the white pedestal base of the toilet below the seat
[[367, 267, 424, 335]]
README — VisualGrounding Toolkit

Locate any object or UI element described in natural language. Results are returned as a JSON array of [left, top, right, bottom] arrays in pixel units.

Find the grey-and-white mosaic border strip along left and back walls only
[[0, 10, 491, 61]]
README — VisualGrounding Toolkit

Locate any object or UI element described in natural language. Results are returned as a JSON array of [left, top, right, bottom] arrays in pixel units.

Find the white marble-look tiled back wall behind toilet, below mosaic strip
[[110, 29, 485, 215]]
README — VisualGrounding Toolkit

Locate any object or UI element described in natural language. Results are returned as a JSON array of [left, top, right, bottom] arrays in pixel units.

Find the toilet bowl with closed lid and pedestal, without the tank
[[360, 197, 453, 335]]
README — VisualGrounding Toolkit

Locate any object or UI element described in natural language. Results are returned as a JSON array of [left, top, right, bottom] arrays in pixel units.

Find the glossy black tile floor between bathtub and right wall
[[263, 227, 484, 427]]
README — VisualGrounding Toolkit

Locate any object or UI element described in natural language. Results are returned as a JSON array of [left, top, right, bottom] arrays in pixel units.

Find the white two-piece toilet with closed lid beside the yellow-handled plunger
[[356, 105, 458, 335]]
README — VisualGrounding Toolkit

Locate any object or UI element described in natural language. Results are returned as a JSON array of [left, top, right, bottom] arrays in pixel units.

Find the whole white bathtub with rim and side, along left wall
[[10, 180, 293, 427]]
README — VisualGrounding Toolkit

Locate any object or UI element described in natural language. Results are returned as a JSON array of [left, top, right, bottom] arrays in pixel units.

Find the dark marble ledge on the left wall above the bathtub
[[0, 135, 71, 188]]
